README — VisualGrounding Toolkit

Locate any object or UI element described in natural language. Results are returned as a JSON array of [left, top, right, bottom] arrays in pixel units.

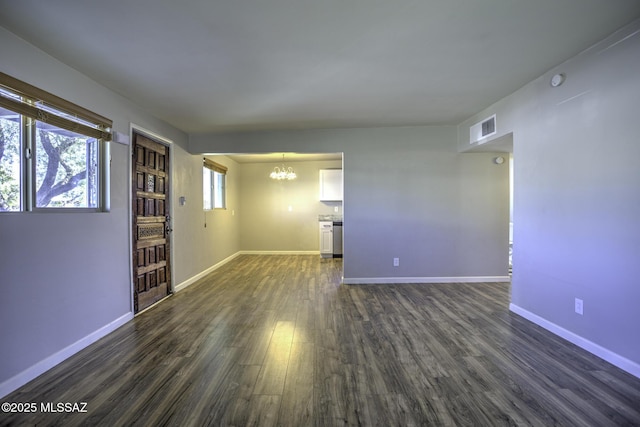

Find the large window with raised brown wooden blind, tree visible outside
[[0, 73, 111, 212]]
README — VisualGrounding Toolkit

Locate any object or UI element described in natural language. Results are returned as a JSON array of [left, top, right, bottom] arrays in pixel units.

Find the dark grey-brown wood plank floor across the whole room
[[0, 256, 640, 426]]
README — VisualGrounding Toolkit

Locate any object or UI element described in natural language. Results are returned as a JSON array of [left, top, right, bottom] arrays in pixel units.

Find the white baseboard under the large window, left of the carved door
[[0, 312, 133, 398]]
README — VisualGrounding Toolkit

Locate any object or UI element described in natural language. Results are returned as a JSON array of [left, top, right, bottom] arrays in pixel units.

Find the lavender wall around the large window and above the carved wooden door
[[0, 28, 190, 396]]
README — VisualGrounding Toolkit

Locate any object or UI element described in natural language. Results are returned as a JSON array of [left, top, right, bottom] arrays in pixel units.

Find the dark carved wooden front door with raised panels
[[132, 132, 171, 313]]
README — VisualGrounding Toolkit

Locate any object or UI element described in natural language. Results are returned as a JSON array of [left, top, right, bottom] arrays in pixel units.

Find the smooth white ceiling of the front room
[[0, 0, 640, 133]]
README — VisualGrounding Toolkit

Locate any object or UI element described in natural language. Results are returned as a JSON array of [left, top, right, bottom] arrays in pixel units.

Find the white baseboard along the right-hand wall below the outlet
[[509, 303, 640, 378]]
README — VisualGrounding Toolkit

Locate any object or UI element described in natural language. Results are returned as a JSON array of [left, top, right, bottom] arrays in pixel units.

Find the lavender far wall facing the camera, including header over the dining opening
[[189, 126, 509, 283]]
